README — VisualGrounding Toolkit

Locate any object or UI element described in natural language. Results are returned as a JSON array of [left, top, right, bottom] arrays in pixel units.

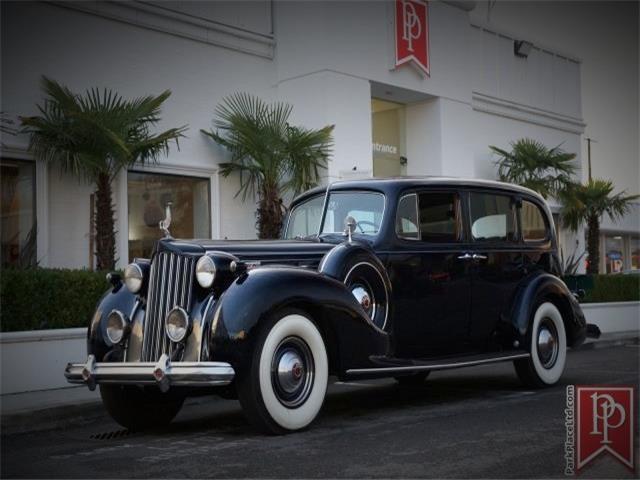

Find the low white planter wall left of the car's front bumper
[[0, 327, 87, 394]]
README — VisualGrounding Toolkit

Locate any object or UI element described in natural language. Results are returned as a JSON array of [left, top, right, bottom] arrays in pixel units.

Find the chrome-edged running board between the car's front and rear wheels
[[346, 352, 529, 376]]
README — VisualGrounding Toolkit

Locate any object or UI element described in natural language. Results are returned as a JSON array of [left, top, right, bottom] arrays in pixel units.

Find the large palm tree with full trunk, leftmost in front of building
[[21, 76, 186, 270]]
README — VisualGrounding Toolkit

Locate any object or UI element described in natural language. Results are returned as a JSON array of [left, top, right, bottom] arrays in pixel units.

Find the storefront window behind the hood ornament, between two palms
[[127, 172, 211, 260]]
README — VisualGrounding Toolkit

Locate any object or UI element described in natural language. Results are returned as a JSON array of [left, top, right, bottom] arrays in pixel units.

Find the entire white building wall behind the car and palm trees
[[1, 1, 639, 267]]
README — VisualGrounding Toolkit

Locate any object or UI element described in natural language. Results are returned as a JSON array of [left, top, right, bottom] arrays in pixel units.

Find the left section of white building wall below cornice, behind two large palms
[[1, 2, 282, 268]]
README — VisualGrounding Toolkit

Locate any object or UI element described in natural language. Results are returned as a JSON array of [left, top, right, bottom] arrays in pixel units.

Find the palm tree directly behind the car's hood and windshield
[[202, 93, 333, 238]]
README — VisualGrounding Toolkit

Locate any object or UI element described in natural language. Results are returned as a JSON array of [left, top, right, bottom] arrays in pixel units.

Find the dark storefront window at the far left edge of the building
[[0, 158, 37, 268]]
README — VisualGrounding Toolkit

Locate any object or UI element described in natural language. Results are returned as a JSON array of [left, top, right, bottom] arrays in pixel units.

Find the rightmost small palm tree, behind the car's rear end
[[560, 179, 640, 274]]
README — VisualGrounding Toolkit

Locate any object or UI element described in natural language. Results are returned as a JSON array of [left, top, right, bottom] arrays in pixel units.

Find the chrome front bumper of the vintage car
[[64, 355, 235, 391]]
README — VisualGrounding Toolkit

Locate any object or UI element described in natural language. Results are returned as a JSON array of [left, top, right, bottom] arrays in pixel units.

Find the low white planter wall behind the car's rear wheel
[[580, 302, 640, 333]]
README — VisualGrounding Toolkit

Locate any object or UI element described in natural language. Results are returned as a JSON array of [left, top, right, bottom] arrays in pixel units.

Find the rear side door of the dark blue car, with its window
[[468, 190, 524, 351]]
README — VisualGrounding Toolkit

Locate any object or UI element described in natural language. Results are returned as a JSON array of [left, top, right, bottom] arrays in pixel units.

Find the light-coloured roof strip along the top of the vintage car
[[294, 176, 545, 203]]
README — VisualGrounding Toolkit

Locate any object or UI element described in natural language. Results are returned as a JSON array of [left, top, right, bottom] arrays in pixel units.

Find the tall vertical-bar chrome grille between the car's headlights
[[140, 252, 196, 362]]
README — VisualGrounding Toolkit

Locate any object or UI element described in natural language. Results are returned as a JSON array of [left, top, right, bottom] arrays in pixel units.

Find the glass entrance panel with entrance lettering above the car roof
[[371, 98, 407, 177]]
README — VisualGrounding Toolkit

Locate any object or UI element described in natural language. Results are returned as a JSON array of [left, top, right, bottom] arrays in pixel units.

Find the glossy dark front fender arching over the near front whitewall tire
[[208, 266, 389, 374]]
